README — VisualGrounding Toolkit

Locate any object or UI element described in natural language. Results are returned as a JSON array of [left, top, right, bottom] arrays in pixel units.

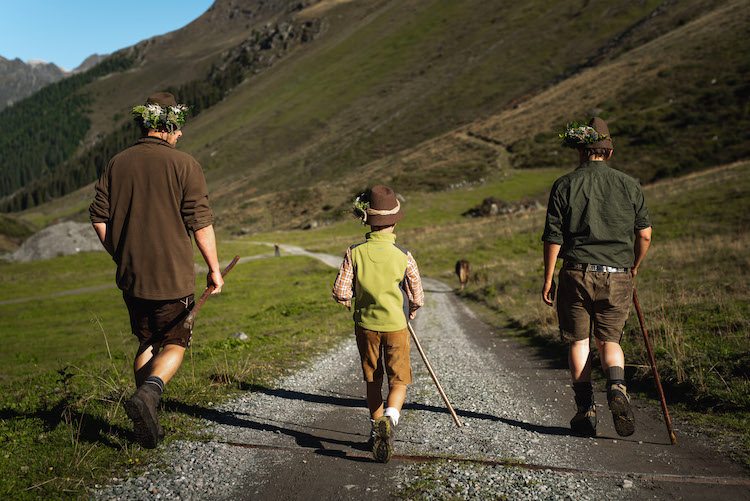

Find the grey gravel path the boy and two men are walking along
[[93, 247, 750, 500]]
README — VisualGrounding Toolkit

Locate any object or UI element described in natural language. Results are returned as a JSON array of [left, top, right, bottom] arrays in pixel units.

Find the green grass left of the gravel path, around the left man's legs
[[0, 256, 350, 499]]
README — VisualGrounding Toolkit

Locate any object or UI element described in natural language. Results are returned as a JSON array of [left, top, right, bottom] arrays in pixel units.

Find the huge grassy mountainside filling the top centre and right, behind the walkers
[[2, 0, 750, 231]]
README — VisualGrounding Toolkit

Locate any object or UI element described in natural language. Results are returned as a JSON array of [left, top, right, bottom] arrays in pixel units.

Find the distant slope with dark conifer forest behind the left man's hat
[[0, 0, 312, 210]]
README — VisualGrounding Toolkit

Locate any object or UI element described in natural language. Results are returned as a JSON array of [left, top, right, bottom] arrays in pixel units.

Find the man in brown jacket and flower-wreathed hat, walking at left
[[89, 92, 224, 448]]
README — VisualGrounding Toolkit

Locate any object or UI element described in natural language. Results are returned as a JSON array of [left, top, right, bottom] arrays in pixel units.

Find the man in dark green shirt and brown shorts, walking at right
[[542, 117, 651, 436]]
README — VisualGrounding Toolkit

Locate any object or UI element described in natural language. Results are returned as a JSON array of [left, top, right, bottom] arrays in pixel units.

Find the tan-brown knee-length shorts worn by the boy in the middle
[[354, 324, 411, 385]]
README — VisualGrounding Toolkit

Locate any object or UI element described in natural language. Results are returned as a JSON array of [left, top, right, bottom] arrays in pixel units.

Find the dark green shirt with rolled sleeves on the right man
[[542, 161, 651, 268]]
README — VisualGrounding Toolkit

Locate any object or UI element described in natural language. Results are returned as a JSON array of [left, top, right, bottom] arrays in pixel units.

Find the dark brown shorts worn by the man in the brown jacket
[[122, 293, 193, 350]]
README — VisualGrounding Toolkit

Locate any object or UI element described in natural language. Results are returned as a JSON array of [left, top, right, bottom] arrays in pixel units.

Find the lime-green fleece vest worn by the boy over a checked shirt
[[351, 232, 409, 332]]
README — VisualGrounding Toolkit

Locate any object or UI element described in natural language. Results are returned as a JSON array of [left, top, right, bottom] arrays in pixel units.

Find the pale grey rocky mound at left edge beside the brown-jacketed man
[[4, 221, 104, 262]]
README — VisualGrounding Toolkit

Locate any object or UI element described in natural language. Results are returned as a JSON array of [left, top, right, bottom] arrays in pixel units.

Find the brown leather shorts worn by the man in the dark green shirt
[[557, 268, 633, 343]]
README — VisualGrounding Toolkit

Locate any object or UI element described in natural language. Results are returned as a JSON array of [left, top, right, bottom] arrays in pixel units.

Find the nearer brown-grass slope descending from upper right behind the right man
[[201, 2, 750, 229]]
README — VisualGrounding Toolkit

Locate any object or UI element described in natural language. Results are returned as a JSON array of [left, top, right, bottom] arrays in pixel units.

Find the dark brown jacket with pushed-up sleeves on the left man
[[89, 137, 214, 300]]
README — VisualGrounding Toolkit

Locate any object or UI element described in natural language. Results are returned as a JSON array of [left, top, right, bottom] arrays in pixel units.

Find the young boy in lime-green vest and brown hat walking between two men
[[333, 186, 424, 463]]
